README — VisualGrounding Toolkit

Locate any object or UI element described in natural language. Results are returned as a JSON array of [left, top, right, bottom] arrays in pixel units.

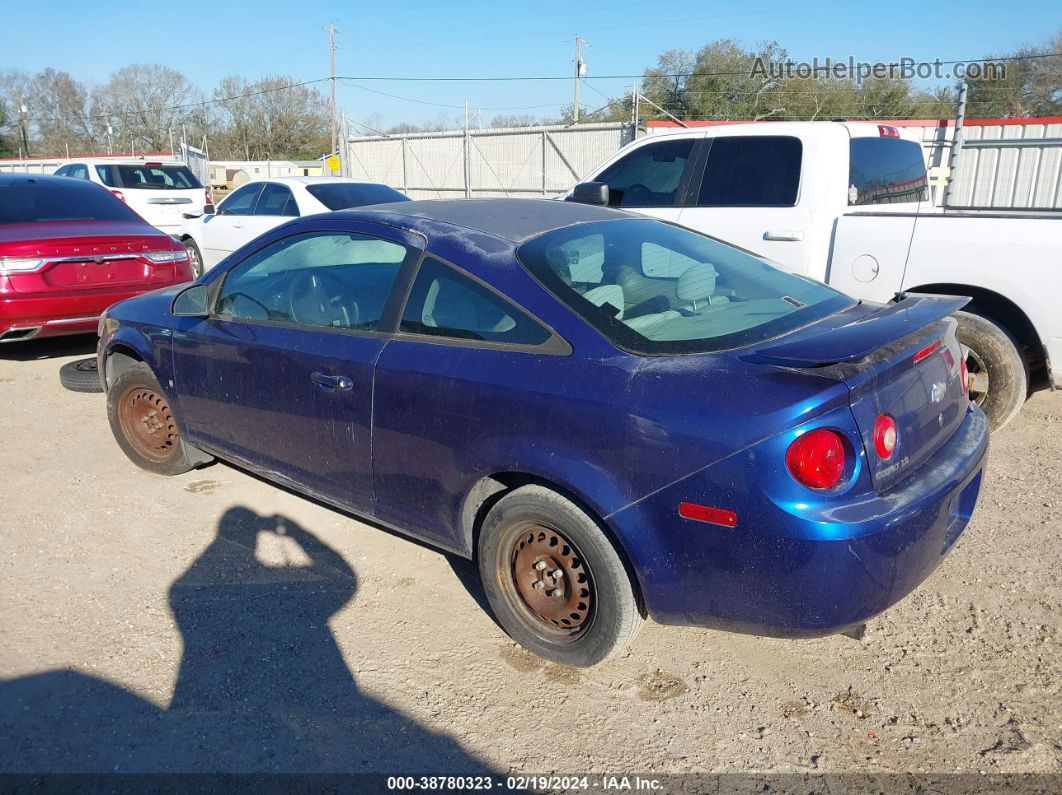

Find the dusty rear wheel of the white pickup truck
[[956, 312, 1029, 431]]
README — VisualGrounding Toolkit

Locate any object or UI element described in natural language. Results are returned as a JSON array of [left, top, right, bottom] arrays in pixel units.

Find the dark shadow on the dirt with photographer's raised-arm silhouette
[[0, 507, 491, 774]]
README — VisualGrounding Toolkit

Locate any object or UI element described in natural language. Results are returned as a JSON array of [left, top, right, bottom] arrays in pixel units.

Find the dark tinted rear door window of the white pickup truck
[[697, 135, 803, 207]]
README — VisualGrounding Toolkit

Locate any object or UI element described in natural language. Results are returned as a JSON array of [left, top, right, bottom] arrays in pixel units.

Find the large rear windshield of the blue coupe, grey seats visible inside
[[517, 219, 853, 353]]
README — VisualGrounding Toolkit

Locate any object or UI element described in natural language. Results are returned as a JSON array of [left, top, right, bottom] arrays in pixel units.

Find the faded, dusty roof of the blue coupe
[[344, 198, 632, 243]]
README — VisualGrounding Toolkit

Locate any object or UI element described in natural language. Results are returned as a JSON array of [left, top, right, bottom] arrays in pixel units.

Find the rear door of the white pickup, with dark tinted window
[[678, 135, 815, 273]]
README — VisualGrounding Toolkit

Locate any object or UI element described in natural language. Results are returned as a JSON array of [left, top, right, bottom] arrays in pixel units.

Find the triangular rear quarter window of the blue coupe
[[399, 257, 550, 345]]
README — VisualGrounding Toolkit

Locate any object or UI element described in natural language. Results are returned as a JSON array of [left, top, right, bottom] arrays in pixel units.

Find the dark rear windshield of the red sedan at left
[[0, 179, 140, 224]]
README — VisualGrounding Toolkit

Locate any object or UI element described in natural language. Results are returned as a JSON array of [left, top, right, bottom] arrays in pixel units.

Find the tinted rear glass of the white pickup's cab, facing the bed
[[849, 138, 928, 205]]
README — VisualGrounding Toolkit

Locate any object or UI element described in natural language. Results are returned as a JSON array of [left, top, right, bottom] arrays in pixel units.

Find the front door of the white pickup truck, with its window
[[593, 136, 699, 221]]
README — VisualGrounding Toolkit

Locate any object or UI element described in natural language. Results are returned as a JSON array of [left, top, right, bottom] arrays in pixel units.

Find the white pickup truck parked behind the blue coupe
[[568, 122, 1062, 428]]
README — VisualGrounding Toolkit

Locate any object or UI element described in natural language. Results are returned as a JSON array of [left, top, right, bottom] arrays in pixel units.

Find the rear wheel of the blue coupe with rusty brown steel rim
[[477, 485, 644, 668]]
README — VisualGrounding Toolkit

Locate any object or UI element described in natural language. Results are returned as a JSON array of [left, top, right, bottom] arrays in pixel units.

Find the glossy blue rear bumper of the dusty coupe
[[610, 407, 989, 637]]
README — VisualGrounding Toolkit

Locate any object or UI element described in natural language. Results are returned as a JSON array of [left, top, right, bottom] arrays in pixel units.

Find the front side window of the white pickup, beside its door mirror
[[597, 138, 693, 207]]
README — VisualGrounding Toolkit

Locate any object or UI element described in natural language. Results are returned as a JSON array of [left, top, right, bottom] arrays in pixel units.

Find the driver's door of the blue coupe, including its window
[[173, 224, 421, 511]]
